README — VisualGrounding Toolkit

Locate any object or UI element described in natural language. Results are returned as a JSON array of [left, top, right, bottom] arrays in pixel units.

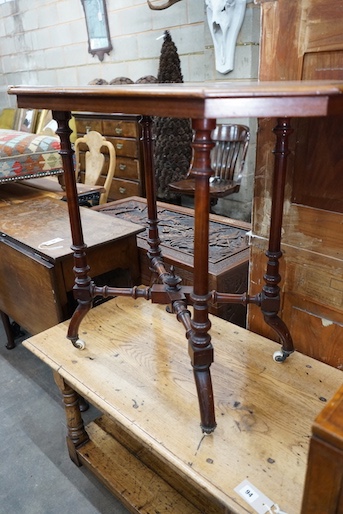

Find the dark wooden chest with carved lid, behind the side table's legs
[[94, 196, 250, 327]]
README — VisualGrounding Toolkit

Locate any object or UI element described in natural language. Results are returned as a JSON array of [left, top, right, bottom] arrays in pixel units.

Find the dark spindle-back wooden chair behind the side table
[[169, 125, 250, 200]]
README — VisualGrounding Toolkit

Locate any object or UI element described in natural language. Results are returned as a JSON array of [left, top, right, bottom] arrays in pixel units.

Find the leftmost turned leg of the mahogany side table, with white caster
[[53, 111, 93, 349]]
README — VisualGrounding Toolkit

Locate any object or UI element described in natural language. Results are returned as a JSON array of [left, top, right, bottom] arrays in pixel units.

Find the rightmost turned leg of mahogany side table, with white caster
[[261, 118, 294, 362]]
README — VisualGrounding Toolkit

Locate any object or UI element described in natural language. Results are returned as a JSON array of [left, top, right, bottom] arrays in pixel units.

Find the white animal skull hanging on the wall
[[205, 0, 247, 73]]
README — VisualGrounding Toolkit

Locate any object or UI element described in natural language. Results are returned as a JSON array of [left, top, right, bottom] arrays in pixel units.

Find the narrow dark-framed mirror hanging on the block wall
[[81, 0, 113, 61]]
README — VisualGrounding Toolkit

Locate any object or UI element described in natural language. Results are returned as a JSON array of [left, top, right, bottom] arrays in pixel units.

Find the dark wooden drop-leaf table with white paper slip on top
[[0, 194, 140, 334]]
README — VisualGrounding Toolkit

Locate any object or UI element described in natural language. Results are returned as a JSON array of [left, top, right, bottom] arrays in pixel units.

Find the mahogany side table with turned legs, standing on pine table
[[9, 81, 343, 433]]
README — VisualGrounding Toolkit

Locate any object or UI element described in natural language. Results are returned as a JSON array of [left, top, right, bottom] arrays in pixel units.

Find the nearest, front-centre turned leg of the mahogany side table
[[189, 119, 216, 433]]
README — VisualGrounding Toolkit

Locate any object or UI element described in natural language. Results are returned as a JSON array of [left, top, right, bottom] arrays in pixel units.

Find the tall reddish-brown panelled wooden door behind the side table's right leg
[[248, 0, 343, 368]]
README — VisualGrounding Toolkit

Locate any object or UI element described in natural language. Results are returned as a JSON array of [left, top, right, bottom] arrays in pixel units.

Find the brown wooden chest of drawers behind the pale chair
[[73, 113, 145, 201]]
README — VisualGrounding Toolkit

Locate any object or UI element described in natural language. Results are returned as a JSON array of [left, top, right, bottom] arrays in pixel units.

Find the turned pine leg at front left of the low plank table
[[54, 371, 89, 466]]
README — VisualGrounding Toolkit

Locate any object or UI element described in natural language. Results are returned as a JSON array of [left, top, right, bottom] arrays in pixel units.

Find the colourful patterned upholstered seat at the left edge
[[0, 129, 63, 184]]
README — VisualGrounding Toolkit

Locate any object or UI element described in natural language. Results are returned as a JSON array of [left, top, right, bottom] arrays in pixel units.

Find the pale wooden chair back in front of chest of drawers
[[75, 130, 116, 204]]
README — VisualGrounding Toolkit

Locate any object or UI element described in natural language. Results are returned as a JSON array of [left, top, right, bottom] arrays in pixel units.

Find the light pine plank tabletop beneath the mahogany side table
[[23, 298, 342, 514]]
